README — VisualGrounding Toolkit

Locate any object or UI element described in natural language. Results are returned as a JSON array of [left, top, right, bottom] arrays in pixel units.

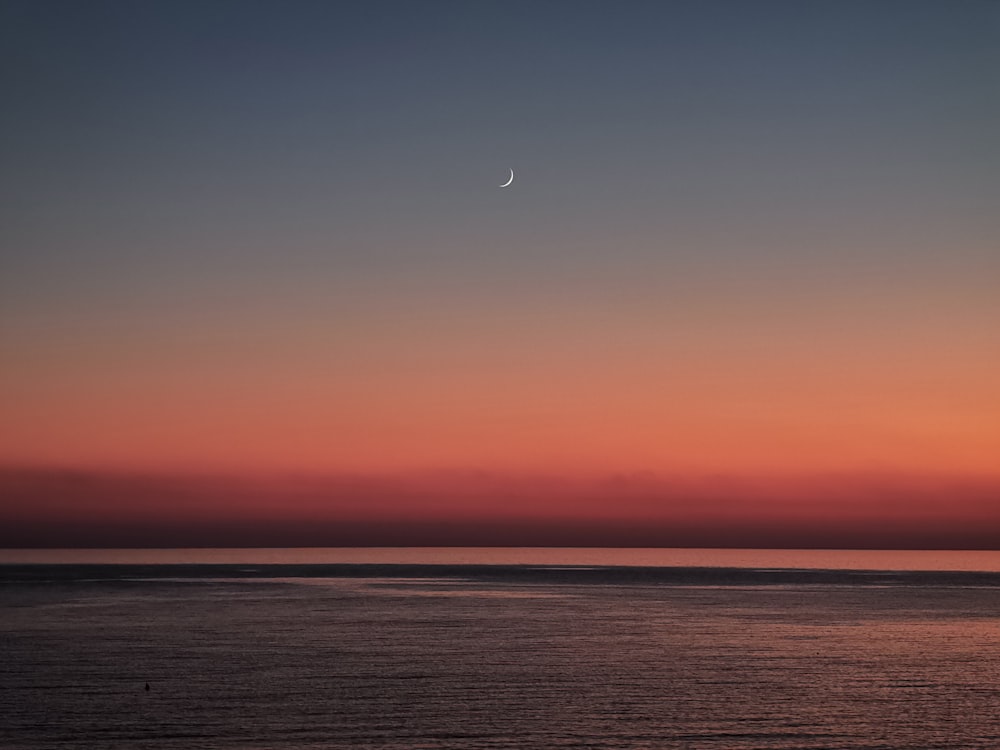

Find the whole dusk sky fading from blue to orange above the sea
[[0, 0, 1000, 546]]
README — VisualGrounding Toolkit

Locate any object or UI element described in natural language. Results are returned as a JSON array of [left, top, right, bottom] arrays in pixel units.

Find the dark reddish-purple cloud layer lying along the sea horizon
[[0, 469, 1000, 549]]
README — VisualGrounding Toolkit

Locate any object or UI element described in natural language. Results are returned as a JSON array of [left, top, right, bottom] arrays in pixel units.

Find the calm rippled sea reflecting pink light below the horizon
[[0, 548, 1000, 750]]
